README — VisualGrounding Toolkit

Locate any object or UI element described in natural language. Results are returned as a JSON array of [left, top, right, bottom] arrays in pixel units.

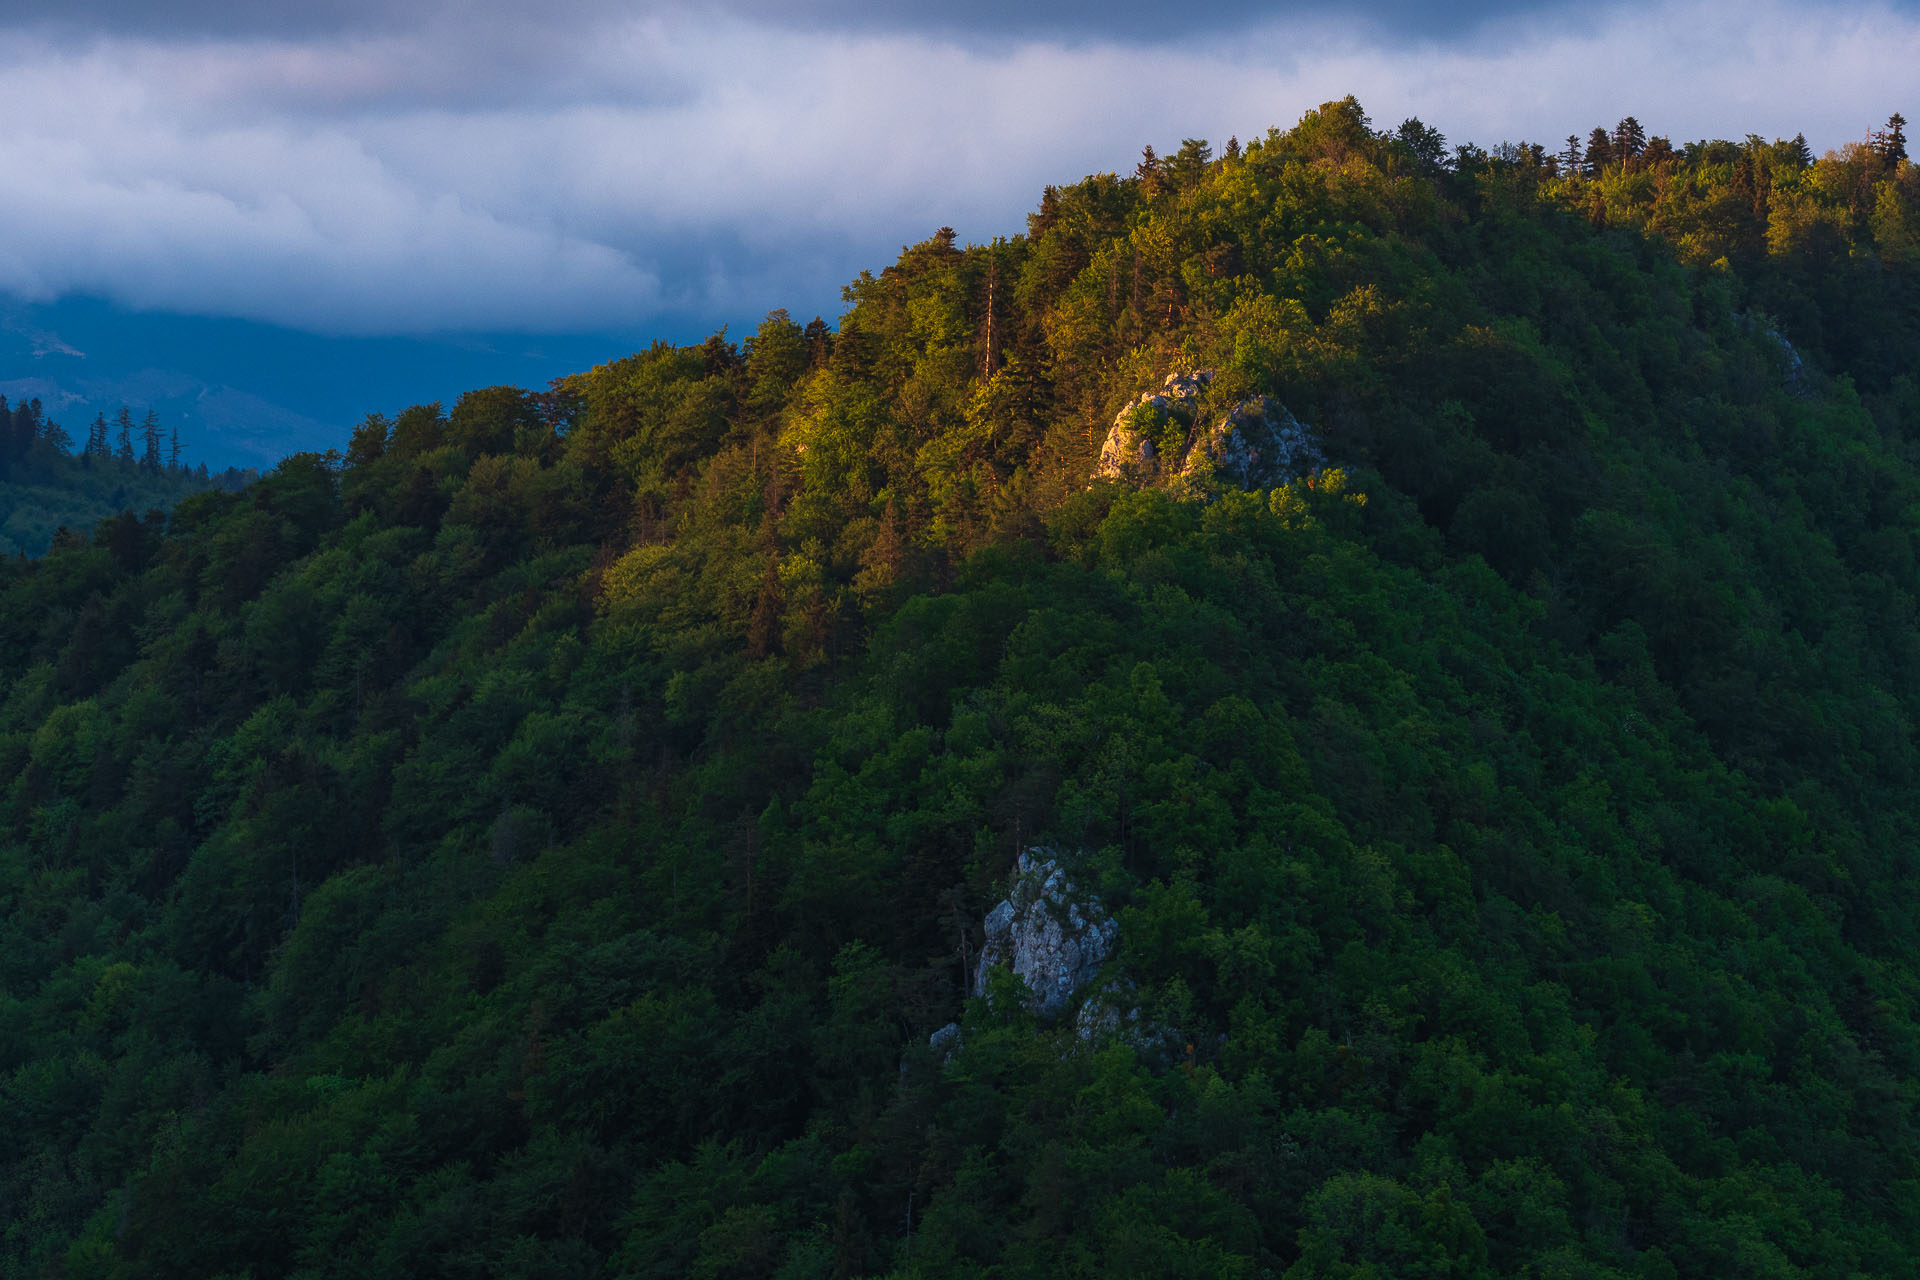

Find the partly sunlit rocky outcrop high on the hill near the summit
[[1094, 368, 1327, 489]]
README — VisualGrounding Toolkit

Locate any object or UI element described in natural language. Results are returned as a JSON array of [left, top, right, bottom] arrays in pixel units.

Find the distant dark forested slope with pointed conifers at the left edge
[[0, 395, 259, 557]]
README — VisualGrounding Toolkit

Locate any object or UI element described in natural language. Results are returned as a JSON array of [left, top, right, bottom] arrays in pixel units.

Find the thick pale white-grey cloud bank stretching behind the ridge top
[[0, 0, 1920, 334]]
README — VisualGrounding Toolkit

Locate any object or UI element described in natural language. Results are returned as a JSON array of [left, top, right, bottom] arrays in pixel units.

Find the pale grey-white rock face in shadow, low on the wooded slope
[[973, 848, 1119, 1017]]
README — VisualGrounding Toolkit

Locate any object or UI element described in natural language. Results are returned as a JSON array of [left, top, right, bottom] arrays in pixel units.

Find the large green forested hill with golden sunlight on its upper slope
[[0, 100, 1920, 1280]]
